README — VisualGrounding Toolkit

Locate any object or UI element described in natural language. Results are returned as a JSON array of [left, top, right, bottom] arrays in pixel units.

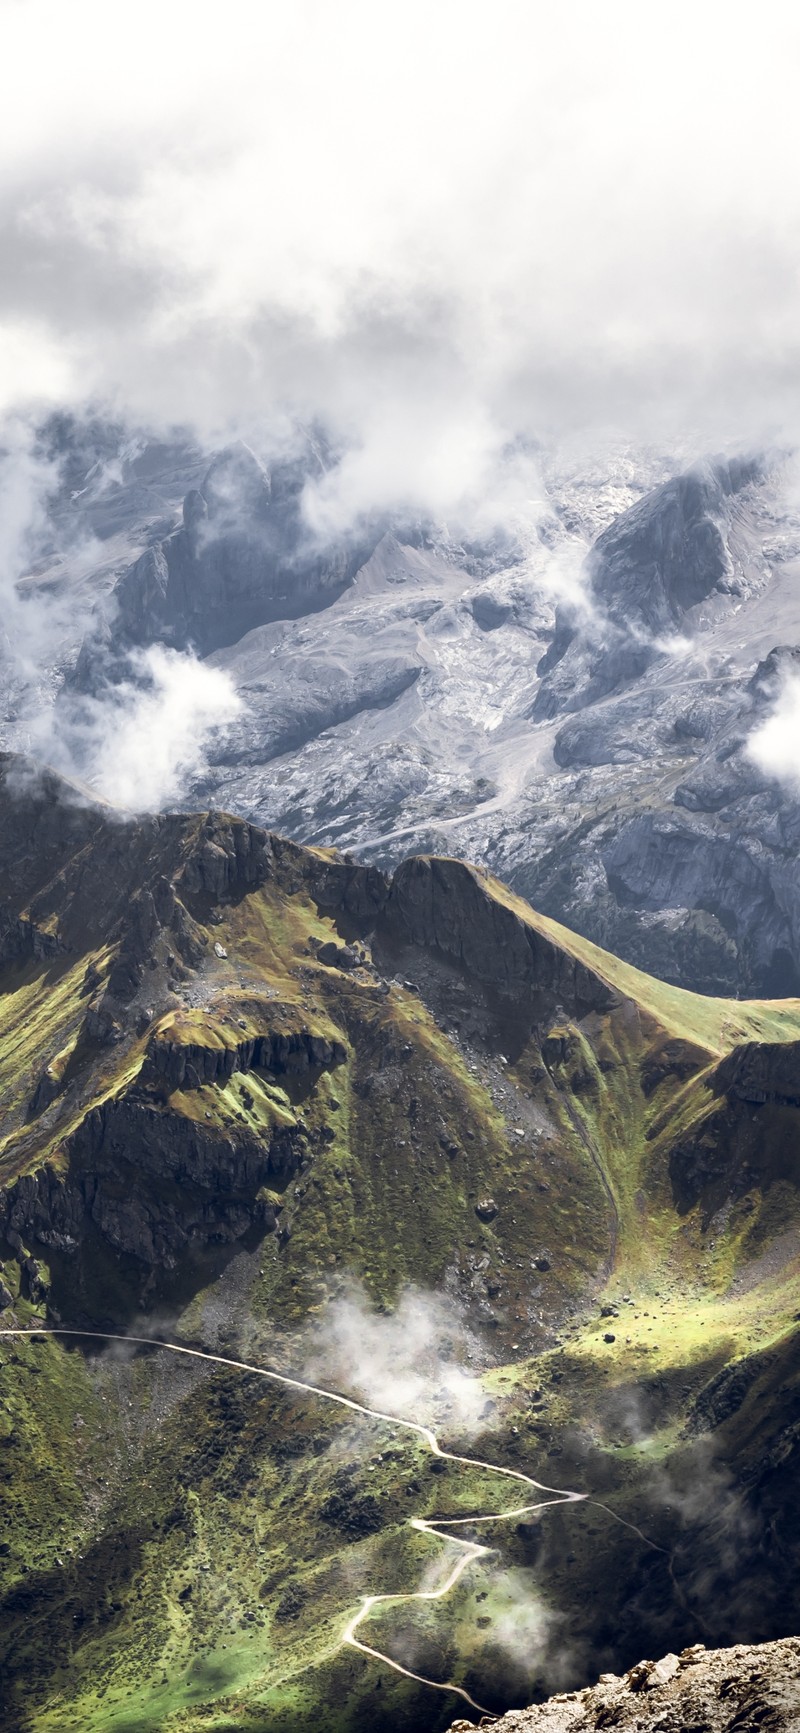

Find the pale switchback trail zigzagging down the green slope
[[0, 1324, 616, 1719]]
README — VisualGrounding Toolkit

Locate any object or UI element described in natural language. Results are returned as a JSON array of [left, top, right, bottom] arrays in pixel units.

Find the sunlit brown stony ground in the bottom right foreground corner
[[450, 1638, 800, 1733]]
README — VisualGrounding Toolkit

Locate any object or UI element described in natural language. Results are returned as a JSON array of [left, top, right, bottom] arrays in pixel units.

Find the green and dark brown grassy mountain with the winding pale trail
[[0, 756, 800, 1733]]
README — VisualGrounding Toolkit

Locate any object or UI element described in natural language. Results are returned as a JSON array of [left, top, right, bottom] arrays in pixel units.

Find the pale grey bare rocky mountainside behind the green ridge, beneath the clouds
[[0, 425, 800, 995]]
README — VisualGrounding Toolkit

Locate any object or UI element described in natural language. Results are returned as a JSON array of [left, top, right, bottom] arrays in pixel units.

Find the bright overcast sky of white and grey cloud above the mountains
[[0, 0, 800, 510]]
